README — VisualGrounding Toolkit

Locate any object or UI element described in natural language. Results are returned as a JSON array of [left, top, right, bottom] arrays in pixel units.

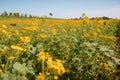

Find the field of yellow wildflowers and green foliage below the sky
[[0, 18, 120, 80]]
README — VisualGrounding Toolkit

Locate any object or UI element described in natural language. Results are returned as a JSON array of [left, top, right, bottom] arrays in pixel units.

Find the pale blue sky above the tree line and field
[[0, 0, 120, 18]]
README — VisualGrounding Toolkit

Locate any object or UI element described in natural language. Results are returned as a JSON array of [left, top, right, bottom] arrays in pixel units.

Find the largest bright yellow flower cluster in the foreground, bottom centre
[[36, 52, 65, 75]]
